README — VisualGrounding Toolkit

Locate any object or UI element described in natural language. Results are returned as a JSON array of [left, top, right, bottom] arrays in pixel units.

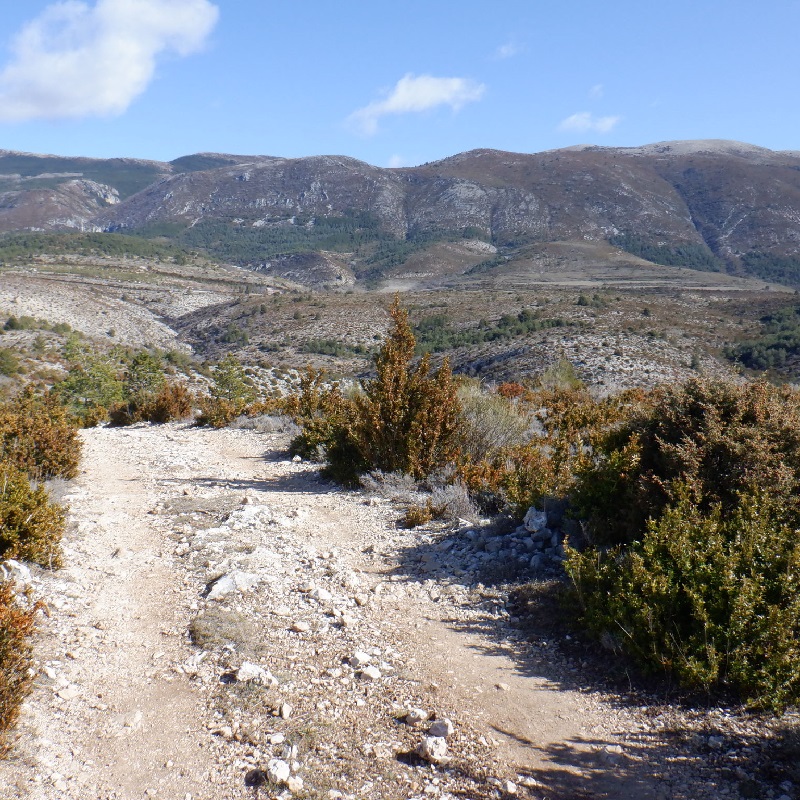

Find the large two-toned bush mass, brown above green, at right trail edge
[[567, 378, 800, 711]]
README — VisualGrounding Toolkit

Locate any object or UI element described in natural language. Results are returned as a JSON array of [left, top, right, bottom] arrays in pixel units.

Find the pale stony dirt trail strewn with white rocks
[[0, 426, 682, 800]]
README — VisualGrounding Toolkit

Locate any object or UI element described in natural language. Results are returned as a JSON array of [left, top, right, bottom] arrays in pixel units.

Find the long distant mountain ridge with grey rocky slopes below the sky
[[0, 140, 800, 286]]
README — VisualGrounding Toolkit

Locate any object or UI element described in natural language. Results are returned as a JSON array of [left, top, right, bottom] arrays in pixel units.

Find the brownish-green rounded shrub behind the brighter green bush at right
[[574, 378, 800, 545]]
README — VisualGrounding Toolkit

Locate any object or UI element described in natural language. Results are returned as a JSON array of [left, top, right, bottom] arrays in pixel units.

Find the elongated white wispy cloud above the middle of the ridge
[[348, 73, 486, 136]]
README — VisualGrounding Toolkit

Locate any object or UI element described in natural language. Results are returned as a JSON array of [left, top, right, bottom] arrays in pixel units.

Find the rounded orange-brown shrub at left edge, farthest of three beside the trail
[[0, 388, 81, 480]]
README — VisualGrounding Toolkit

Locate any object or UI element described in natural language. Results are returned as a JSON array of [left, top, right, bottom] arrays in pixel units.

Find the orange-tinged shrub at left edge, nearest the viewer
[[0, 581, 39, 754]]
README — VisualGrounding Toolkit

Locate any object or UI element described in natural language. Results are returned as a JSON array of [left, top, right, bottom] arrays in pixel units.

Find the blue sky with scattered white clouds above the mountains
[[0, 0, 800, 167]]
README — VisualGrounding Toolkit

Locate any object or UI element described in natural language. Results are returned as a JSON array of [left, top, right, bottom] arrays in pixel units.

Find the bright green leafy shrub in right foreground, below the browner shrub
[[567, 485, 800, 711]]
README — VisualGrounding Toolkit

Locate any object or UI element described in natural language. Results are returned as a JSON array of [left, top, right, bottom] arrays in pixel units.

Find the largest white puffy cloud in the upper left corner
[[0, 0, 219, 122]]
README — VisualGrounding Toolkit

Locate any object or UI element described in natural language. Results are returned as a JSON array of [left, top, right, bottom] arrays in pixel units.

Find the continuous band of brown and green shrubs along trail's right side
[[289, 303, 800, 712]]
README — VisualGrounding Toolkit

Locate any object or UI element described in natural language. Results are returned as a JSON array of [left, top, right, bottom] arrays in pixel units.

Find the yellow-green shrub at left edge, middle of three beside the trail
[[0, 464, 66, 568]]
